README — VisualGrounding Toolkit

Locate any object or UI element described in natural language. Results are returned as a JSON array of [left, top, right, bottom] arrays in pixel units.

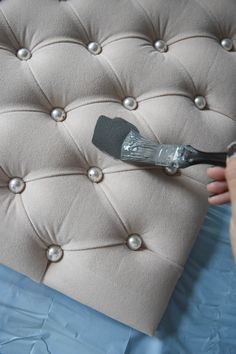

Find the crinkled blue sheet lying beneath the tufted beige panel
[[0, 205, 236, 354]]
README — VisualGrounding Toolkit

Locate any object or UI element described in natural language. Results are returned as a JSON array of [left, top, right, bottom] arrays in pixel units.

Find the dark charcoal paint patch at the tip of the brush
[[92, 115, 139, 159]]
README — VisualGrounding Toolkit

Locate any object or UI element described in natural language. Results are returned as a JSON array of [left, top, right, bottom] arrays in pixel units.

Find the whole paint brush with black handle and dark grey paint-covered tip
[[92, 115, 227, 169]]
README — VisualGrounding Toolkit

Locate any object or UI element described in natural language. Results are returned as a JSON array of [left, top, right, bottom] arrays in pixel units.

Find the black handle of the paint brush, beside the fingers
[[188, 149, 227, 167]]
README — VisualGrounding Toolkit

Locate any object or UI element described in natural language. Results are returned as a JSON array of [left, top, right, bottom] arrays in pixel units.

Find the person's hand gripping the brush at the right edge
[[207, 142, 236, 259]]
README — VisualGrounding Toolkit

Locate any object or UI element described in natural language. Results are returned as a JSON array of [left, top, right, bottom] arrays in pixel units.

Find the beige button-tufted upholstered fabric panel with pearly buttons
[[0, 0, 236, 335]]
